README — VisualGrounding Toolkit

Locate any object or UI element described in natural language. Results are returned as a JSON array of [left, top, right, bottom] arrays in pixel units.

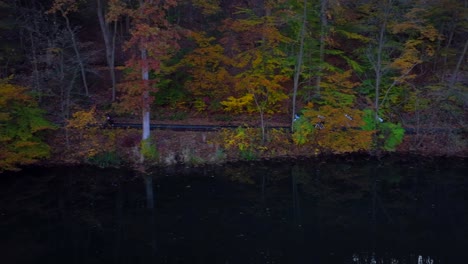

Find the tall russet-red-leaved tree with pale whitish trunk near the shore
[[112, 0, 179, 159]]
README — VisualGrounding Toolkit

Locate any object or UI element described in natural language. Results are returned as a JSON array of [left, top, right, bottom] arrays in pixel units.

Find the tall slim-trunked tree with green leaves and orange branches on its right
[[352, 0, 439, 120]]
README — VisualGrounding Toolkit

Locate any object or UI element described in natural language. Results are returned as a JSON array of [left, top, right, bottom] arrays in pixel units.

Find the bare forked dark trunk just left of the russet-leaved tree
[[96, 0, 117, 101]]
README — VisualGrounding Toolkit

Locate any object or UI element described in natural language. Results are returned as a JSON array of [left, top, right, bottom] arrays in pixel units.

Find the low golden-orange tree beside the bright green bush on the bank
[[293, 70, 374, 153]]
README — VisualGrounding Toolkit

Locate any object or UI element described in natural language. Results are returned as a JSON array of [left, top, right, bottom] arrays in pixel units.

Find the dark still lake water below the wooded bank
[[0, 158, 468, 264]]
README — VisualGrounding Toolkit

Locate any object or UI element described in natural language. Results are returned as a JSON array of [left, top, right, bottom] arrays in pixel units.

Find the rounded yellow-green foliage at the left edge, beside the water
[[0, 80, 55, 172]]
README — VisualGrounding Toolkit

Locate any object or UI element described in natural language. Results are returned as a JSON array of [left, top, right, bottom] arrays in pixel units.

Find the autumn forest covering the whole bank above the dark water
[[0, 0, 468, 171]]
